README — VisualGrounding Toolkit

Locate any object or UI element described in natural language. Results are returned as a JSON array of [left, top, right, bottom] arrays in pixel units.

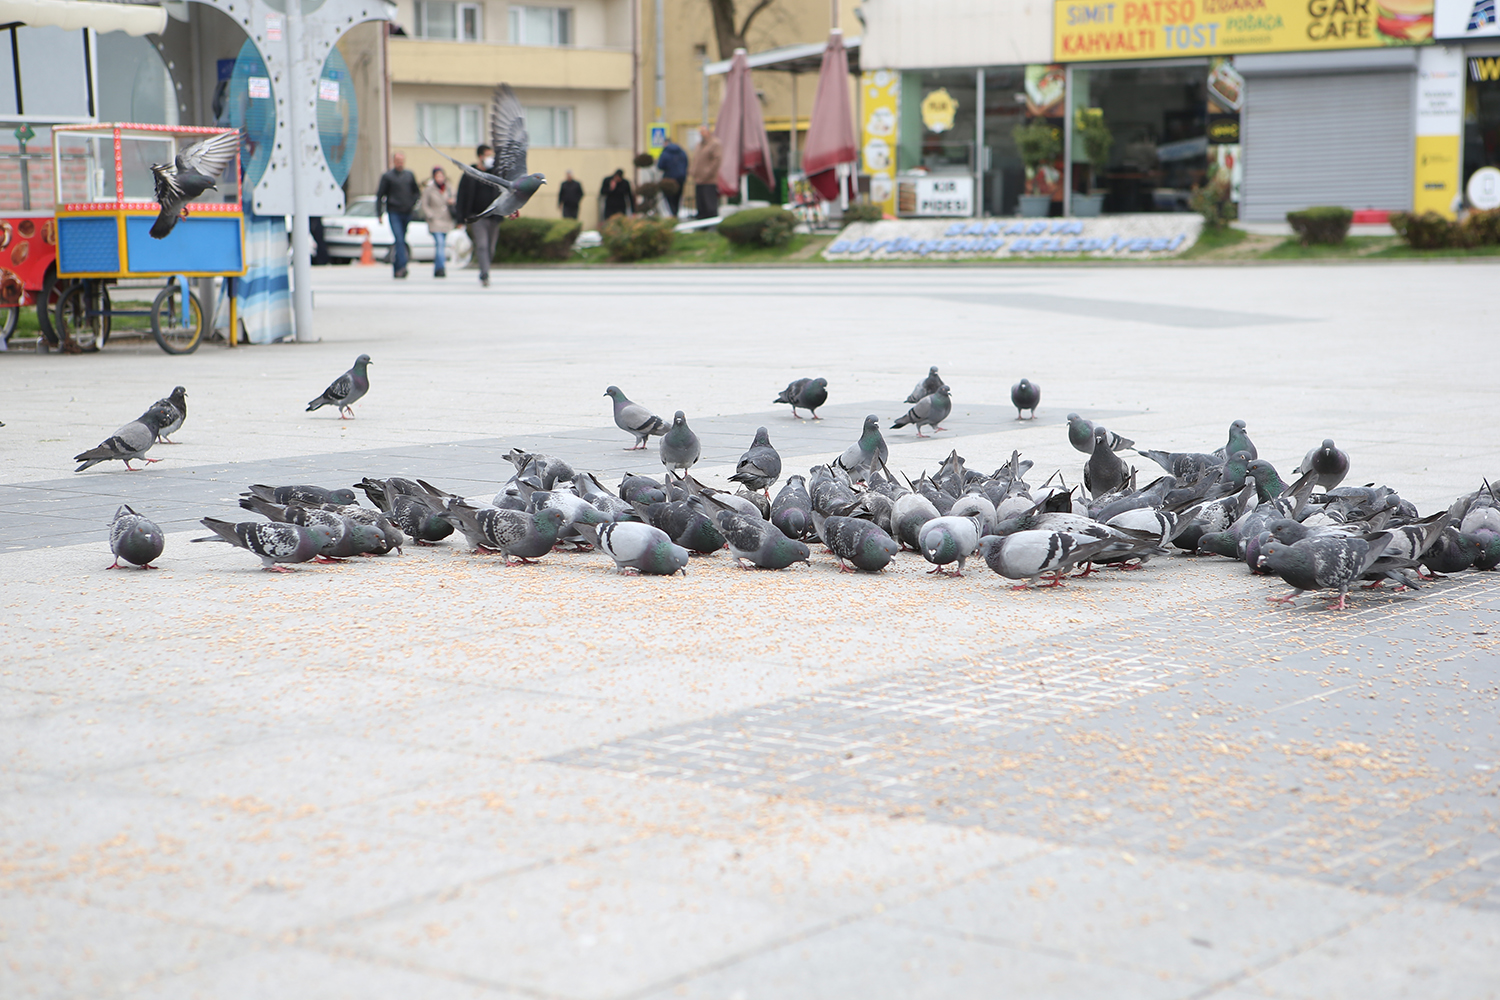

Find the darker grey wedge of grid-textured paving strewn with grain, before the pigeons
[[551, 574, 1500, 910]]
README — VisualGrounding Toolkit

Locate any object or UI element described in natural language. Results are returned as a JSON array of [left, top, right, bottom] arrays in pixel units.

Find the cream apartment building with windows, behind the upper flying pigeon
[[387, 0, 638, 226]]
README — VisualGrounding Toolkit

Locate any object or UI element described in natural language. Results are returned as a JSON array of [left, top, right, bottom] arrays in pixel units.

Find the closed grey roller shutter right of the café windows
[[1241, 72, 1416, 222]]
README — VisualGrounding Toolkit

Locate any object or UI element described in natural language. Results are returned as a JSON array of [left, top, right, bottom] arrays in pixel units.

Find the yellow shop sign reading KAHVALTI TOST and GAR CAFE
[[1052, 0, 1433, 63]]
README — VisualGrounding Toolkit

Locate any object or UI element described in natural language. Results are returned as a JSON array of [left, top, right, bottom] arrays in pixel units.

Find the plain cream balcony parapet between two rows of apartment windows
[[390, 37, 632, 90]]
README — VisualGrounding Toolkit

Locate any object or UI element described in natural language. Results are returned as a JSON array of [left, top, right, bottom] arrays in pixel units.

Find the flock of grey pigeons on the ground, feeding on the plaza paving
[[78, 355, 1500, 609]]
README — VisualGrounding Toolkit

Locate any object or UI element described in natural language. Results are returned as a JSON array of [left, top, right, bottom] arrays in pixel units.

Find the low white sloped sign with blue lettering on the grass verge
[[824, 213, 1203, 261]]
